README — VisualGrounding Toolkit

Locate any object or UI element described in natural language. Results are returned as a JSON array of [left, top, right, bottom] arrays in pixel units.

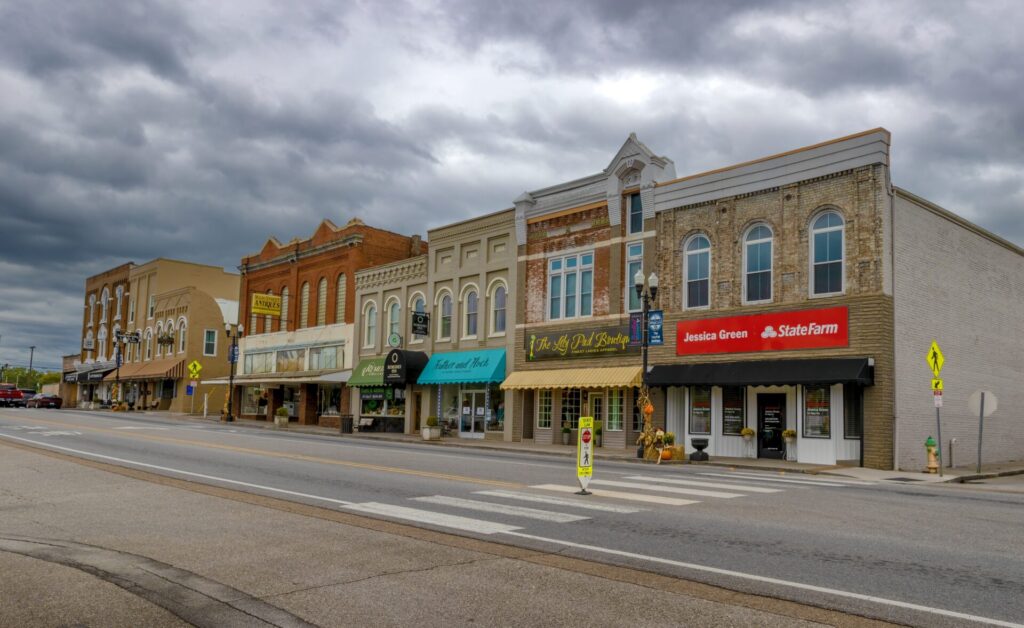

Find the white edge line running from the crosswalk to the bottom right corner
[[503, 531, 1024, 628]]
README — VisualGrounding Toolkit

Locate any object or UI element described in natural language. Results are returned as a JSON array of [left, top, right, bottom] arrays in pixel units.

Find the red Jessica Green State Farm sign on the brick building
[[676, 307, 850, 355]]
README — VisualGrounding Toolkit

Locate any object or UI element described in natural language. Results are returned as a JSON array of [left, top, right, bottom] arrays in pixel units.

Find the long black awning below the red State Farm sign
[[647, 358, 874, 386]]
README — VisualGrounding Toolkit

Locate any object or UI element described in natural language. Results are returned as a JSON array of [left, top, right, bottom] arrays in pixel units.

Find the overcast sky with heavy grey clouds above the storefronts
[[0, 0, 1024, 368]]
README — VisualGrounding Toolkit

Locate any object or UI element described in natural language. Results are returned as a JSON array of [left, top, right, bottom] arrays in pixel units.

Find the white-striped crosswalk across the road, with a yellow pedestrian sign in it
[[344, 471, 873, 535]]
